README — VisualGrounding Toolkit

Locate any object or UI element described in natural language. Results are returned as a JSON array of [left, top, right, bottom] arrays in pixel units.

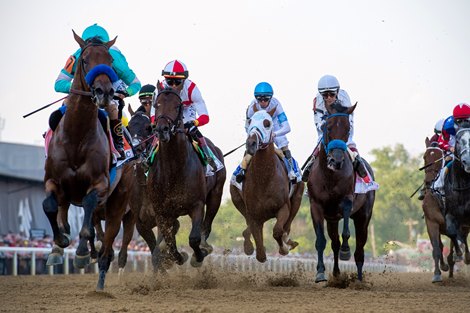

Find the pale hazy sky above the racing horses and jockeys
[[0, 0, 470, 197]]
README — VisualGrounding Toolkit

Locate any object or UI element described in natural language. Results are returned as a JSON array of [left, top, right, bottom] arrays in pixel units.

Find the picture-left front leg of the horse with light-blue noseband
[[310, 198, 327, 283]]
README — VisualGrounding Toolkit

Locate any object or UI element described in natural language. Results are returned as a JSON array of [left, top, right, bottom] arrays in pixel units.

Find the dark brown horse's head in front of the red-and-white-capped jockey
[[153, 82, 183, 142]]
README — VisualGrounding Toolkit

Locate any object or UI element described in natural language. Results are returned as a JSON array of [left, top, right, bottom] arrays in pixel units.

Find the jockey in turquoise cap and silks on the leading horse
[[49, 24, 141, 160]]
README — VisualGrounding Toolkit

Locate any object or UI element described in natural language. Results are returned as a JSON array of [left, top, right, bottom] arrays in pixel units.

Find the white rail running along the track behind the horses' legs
[[0, 247, 421, 276]]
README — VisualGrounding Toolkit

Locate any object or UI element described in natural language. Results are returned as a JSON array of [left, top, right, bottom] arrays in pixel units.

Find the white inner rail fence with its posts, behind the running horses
[[0, 247, 422, 276]]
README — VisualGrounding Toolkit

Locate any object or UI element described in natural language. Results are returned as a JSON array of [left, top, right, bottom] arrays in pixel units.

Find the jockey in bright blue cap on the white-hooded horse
[[235, 82, 297, 183]]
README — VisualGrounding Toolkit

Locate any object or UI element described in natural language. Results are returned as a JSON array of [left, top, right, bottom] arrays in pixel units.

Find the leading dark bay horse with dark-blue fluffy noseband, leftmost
[[43, 32, 120, 268]]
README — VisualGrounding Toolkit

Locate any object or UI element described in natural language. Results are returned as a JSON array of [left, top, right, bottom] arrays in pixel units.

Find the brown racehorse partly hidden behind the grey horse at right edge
[[422, 137, 449, 283]]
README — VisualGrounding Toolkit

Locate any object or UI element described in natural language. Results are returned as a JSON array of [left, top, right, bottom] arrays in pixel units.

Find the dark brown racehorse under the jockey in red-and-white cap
[[147, 82, 226, 271]]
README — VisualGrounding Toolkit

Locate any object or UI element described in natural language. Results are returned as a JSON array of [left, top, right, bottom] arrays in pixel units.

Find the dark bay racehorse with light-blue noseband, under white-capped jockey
[[307, 103, 375, 283]]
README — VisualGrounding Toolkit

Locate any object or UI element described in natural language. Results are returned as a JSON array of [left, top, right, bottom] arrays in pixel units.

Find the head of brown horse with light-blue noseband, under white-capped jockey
[[322, 102, 357, 170]]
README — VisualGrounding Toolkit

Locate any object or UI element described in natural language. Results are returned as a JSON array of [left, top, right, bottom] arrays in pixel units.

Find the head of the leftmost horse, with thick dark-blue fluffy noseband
[[72, 31, 118, 107]]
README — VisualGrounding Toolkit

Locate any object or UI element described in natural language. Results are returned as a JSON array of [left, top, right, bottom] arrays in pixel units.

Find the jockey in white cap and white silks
[[302, 75, 372, 183]]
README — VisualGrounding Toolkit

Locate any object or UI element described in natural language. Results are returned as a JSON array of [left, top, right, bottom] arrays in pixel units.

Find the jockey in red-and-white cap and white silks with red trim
[[151, 60, 223, 171]]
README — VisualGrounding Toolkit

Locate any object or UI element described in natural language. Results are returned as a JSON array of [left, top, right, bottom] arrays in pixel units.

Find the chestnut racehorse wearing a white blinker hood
[[230, 108, 304, 262]]
